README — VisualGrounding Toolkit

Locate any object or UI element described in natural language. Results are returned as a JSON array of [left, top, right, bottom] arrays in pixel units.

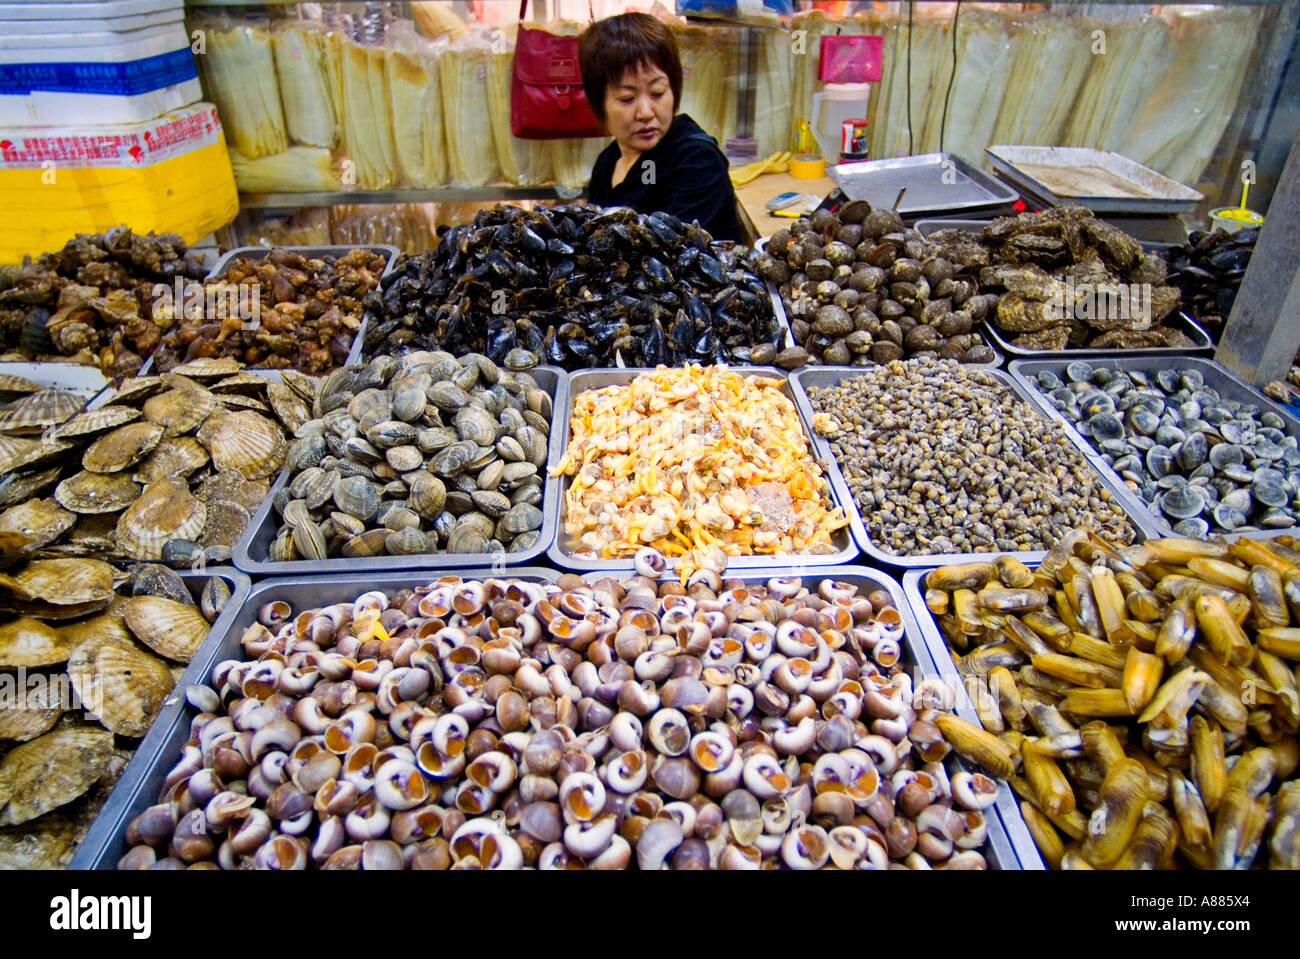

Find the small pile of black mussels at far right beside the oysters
[[1161, 227, 1260, 342]]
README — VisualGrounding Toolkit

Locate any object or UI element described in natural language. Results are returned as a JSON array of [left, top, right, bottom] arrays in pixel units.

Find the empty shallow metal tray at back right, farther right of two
[[984, 144, 1205, 213]]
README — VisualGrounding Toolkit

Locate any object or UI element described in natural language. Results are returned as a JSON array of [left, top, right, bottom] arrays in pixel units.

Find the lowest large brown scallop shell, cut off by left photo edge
[[0, 726, 113, 825]]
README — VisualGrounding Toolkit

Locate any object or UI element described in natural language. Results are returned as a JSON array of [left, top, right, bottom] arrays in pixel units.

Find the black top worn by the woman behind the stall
[[588, 113, 741, 243]]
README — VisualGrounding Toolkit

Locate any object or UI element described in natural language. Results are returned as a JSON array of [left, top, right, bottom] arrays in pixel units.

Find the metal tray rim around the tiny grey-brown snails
[[790, 366, 1158, 569]]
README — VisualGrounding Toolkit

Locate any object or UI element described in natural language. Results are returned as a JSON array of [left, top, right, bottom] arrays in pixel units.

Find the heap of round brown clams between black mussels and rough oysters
[[757, 200, 996, 369]]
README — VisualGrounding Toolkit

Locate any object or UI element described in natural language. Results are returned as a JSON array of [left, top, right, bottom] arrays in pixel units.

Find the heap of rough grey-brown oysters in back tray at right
[[930, 207, 1192, 350]]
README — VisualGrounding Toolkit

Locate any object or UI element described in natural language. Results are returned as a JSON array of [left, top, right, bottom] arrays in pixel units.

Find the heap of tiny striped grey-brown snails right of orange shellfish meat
[[807, 360, 1134, 556]]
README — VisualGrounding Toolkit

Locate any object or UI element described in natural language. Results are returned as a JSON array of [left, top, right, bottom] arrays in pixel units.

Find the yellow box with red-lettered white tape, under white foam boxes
[[0, 103, 239, 262]]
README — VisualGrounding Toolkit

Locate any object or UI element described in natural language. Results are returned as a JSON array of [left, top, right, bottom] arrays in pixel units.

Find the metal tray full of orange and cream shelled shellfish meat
[[549, 365, 858, 572]]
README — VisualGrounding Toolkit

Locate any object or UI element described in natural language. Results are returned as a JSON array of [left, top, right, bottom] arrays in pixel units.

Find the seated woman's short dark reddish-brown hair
[[577, 13, 681, 123]]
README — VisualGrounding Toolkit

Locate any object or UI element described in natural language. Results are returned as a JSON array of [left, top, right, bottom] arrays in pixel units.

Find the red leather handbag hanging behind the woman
[[510, 0, 601, 140]]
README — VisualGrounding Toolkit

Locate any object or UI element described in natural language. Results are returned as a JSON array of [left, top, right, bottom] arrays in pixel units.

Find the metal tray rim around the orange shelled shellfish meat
[[546, 366, 858, 573]]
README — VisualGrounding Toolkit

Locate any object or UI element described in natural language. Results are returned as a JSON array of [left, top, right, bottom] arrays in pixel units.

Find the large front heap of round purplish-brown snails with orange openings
[[118, 572, 1009, 869]]
